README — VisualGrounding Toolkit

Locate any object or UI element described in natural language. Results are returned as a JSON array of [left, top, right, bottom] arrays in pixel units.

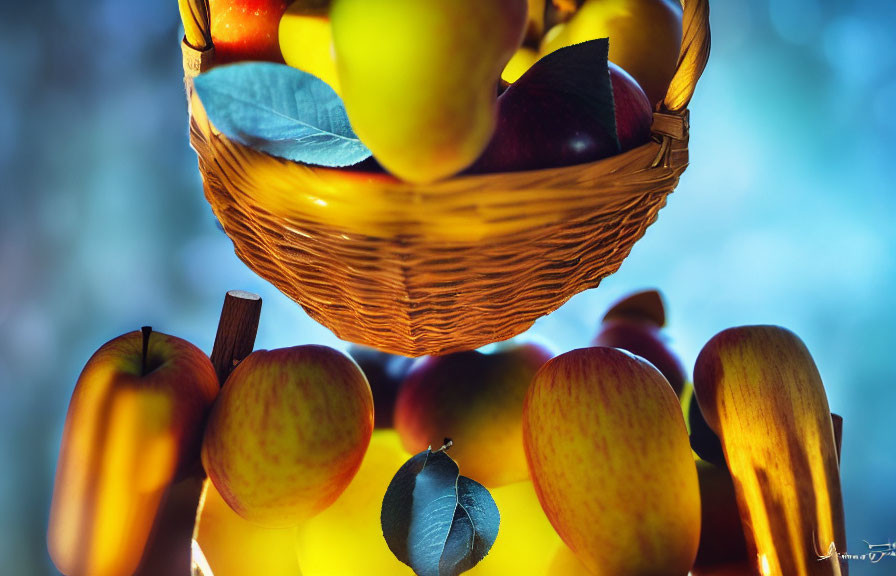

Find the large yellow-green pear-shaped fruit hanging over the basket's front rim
[[330, 0, 527, 182]]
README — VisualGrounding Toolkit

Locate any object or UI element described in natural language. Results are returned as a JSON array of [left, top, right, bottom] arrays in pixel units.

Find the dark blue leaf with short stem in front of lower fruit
[[381, 450, 500, 576]]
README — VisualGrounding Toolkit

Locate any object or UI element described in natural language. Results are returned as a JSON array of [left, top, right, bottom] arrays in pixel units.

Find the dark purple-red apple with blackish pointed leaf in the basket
[[469, 40, 653, 173]]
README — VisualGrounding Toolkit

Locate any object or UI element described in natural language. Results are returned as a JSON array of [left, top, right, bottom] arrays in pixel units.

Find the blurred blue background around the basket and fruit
[[0, 0, 896, 576]]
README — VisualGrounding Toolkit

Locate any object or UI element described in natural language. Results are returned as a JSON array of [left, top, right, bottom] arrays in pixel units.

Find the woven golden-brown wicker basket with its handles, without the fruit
[[182, 0, 709, 356]]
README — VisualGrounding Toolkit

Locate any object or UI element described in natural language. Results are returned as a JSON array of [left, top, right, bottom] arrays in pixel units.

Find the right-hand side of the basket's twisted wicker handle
[[663, 0, 710, 113]]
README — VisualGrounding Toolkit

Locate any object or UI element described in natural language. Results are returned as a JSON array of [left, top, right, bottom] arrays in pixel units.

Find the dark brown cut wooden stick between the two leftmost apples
[[135, 290, 261, 576]]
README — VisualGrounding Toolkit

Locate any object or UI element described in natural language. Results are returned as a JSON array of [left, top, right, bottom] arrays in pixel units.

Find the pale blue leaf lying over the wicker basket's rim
[[194, 62, 371, 167]]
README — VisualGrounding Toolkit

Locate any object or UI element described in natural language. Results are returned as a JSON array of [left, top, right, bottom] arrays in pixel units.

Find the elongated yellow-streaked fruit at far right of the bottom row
[[694, 326, 846, 576]]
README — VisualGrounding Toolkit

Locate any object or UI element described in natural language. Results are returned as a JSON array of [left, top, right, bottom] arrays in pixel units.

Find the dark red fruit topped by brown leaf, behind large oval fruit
[[592, 290, 687, 396]]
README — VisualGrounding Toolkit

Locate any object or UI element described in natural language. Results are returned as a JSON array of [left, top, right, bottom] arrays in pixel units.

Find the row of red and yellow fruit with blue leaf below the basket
[[48, 291, 845, 576]]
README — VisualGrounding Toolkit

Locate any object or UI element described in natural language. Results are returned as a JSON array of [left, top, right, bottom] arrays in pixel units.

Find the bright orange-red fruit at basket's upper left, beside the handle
[[208, 0, 288, 63]]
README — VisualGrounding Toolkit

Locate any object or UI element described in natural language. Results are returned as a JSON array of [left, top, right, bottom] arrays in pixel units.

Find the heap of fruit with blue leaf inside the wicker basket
[[181, 0, 682, 183]]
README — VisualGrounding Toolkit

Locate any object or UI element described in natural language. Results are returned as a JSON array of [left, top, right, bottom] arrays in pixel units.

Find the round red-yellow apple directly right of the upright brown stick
[[202, 345, 373, 527]]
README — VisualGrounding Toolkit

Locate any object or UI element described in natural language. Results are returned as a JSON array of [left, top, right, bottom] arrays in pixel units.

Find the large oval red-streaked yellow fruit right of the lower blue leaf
[[523, 347, 700, 576]]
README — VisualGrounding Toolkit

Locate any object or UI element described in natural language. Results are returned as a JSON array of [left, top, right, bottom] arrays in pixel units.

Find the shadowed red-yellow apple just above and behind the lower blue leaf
[[395, 344, 551, 487]]
